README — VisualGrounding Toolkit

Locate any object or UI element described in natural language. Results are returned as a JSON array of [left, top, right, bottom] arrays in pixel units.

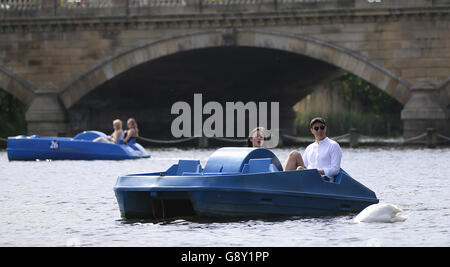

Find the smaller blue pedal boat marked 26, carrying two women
[[6, 131, 150, 161]]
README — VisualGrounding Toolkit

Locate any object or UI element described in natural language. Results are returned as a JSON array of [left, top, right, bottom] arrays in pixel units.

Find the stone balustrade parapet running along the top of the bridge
[[0, 0, 450, 19]]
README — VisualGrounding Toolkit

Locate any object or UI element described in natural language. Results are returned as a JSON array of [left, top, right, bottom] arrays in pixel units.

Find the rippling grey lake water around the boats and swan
[[0, 148, 450, 246]]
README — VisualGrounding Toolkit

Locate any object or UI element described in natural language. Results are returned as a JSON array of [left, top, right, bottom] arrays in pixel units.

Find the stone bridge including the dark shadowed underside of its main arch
[[0, 0, 450, 138]]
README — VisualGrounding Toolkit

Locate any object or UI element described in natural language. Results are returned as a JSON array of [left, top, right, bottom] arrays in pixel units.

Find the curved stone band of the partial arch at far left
[[0, 66, 34, 106]]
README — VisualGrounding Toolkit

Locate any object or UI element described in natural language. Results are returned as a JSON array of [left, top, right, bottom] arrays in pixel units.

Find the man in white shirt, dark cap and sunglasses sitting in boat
[[284, 117, 342, 181]]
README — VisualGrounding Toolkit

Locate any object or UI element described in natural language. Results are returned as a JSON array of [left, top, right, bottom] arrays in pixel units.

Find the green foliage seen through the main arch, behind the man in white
[[296, 73, 403, 136]]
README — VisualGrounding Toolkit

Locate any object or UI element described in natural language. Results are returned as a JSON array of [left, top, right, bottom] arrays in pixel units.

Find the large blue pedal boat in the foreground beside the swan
[[114, 148, 378, 220]]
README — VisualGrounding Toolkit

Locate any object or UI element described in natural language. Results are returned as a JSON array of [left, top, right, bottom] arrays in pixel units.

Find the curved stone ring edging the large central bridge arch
[[60, 29, 411, 108]]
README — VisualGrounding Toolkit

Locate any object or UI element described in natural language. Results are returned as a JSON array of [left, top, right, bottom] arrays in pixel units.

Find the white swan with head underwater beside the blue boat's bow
[[353, 203, 408, 223]]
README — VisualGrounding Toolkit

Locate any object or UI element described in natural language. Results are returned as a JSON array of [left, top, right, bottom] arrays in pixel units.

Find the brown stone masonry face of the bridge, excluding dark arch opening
[[0, 0, 450, 138]]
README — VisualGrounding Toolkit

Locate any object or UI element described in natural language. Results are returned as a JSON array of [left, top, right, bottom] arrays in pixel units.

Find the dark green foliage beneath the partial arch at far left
[[0, 89, 27, 137]]
